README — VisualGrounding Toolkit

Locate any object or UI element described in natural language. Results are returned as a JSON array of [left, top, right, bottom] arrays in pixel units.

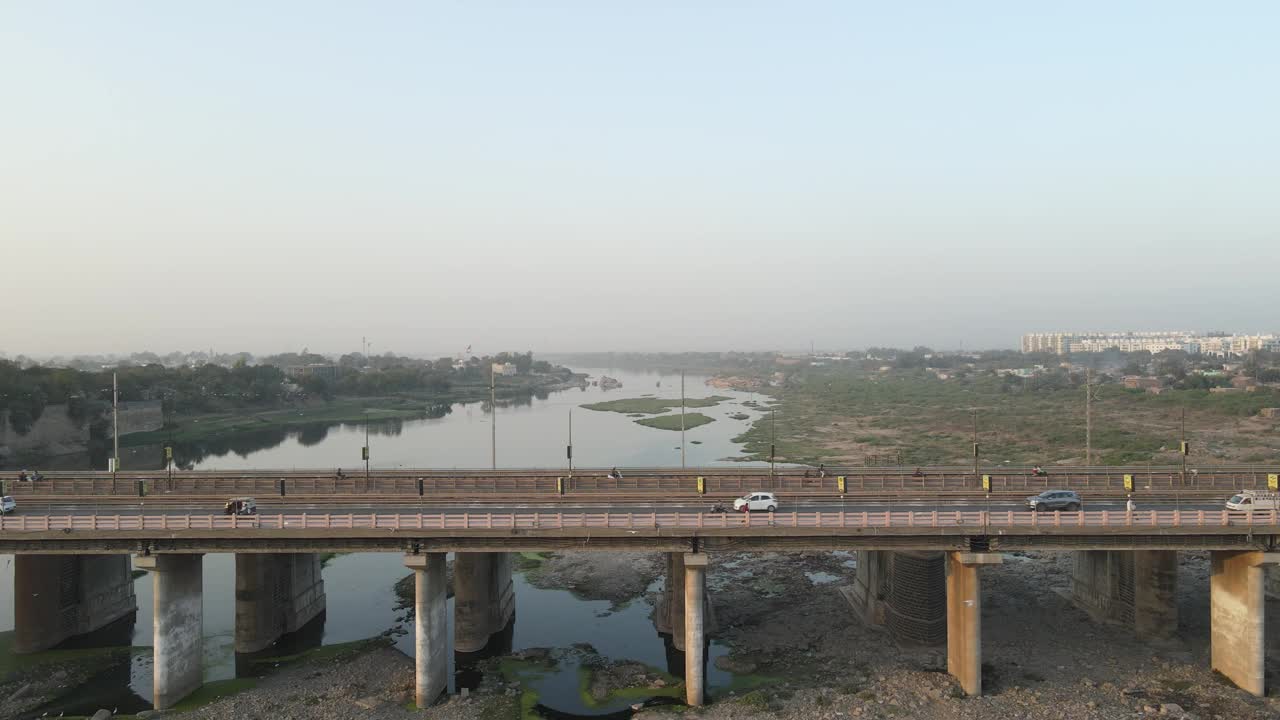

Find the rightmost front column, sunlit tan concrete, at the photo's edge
[[1208, 550, 1280, 697]]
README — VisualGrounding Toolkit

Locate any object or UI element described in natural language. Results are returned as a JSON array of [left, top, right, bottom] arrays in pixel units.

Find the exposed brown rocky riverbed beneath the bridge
[[35, 552, 1280, 720]]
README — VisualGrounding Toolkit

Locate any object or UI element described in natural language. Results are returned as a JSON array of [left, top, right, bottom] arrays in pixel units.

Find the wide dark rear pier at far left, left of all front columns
[[13, 555, 138, 653]]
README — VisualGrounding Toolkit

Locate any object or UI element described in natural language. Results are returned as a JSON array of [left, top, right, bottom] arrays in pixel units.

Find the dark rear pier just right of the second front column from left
[[453, 552, 516, 652]]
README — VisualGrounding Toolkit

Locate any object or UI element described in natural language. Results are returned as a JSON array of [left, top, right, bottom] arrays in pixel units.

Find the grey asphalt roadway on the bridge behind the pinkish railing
[[18, 497, 1224, 516]]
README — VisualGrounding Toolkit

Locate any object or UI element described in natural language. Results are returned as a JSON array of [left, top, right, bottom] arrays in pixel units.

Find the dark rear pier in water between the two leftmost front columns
[[236, 552, 325, 652]]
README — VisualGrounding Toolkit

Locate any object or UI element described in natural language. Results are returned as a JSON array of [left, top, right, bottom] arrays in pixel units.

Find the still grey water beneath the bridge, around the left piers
[[0, 553, 732, 717]]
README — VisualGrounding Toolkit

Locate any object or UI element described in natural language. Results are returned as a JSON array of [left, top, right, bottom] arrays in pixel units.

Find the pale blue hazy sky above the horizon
[[0, 0, 1280, 354]]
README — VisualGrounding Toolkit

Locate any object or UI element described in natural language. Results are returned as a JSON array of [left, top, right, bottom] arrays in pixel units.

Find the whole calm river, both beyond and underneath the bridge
[[0, 369, 760, 716]]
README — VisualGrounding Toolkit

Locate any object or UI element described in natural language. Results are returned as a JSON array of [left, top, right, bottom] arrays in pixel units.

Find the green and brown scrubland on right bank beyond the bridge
[[735, 350, 1280, 465]]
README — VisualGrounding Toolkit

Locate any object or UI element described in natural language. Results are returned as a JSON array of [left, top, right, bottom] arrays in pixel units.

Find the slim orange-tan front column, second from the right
[[946, 552, 1004, 696]]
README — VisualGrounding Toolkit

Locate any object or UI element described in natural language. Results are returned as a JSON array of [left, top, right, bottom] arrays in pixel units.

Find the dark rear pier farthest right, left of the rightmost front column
[[1071, 550, 1178, 638]]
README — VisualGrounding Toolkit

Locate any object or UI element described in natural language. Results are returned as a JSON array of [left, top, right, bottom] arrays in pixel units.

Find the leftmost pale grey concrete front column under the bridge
[[137, 555, 205, 710]]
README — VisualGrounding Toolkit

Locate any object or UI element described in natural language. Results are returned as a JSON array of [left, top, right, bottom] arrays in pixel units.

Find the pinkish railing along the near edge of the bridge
[[0, 510, 1280, 533]]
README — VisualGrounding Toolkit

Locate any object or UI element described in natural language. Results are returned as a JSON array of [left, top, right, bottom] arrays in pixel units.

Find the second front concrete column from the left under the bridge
[[404, 552, 457, 708]]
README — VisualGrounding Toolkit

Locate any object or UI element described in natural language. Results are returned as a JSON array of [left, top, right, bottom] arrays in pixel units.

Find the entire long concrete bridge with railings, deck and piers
[[0, 468, 1280, 708]]
